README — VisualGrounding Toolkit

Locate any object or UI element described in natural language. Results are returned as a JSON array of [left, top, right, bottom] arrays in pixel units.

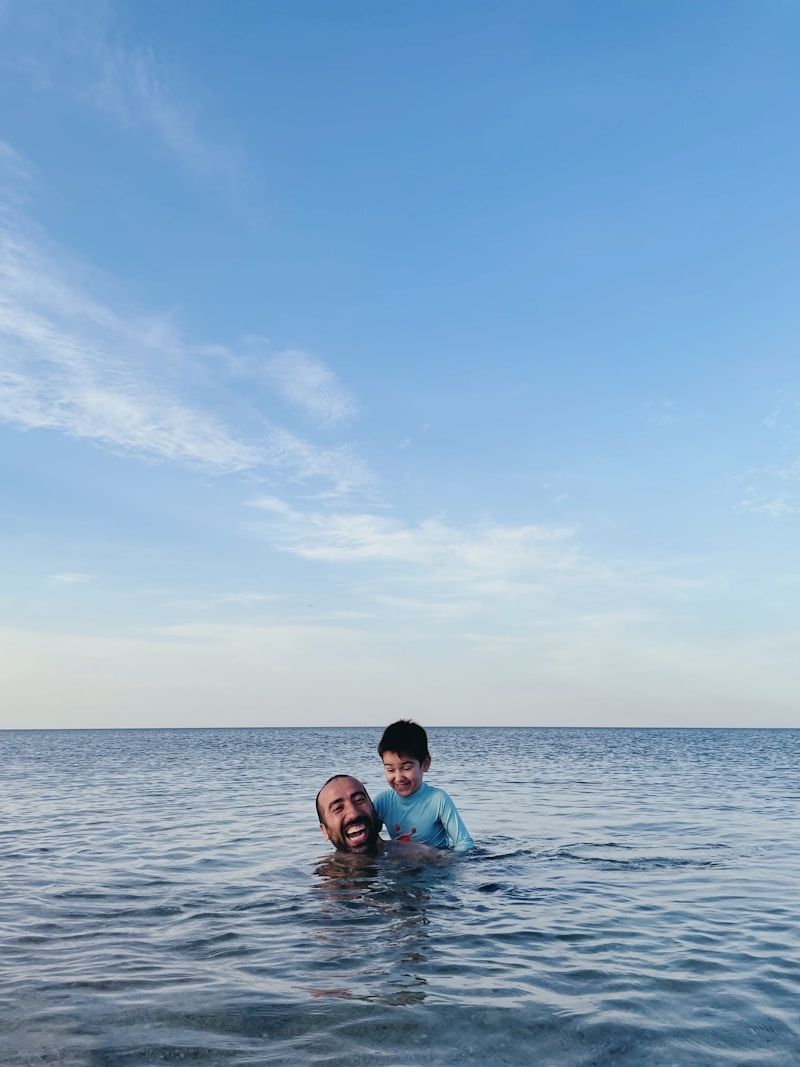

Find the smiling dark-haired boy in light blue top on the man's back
[[373, 719, 474, 853]]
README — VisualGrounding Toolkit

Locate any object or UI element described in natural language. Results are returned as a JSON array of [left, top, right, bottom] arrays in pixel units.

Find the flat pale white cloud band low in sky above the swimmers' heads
[[249, 495, 715, 636]]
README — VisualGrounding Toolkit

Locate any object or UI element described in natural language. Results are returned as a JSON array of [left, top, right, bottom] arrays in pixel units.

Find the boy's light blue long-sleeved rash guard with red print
[[372, 782, 475, 853]]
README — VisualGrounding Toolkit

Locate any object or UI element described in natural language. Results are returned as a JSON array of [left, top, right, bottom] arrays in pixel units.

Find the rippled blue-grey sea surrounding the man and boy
[[0, 729, 800, 1067]]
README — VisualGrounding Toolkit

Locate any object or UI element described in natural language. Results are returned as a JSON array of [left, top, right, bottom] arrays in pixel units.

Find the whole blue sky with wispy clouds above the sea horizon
[[0, 0, 800, 728]]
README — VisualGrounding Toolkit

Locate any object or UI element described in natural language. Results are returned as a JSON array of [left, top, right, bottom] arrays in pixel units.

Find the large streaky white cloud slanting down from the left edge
[[0, 197, 369, 494]]
